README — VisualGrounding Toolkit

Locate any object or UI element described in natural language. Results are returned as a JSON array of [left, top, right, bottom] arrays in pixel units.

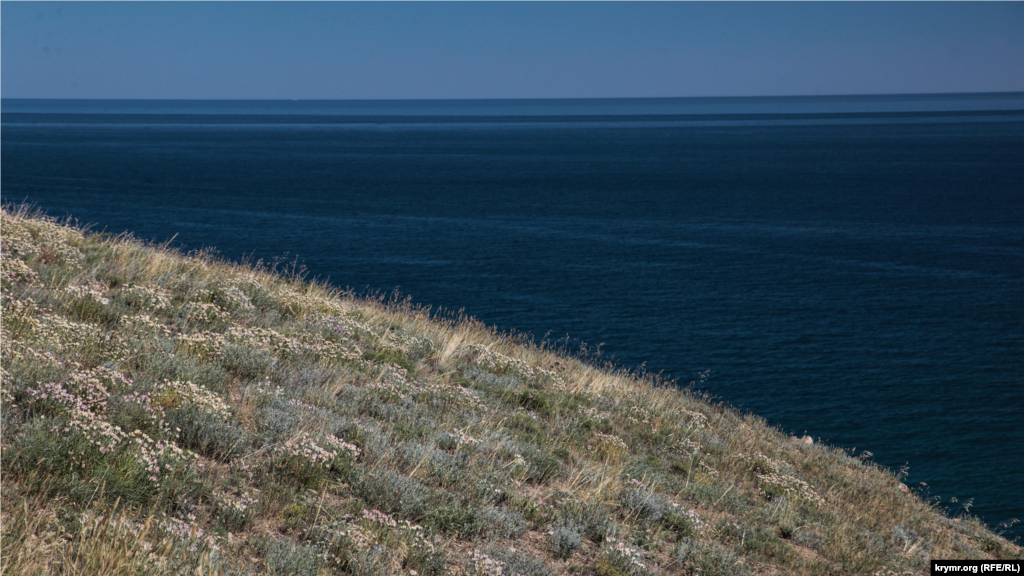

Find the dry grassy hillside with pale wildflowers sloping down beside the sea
[[0, 203, 1021, 576]]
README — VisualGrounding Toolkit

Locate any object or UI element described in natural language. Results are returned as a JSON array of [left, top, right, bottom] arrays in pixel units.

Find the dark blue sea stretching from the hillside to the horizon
[[0, 93, 1024, 536]]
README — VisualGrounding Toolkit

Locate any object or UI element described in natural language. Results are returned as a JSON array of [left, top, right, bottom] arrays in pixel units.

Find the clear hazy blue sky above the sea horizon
[[0, 0, 1024, 98]]
